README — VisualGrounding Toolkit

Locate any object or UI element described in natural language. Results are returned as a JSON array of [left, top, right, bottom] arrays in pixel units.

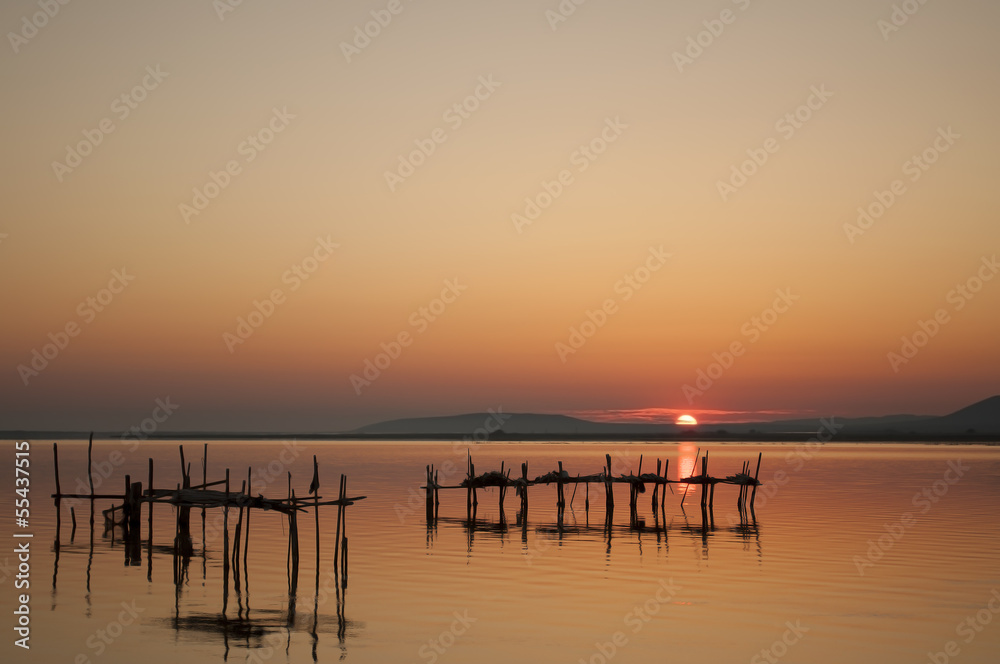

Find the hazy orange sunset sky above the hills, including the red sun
[[0, 0, 1000, 432]]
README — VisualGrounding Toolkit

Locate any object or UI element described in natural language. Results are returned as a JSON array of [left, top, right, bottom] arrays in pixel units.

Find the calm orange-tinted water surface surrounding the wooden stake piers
[[0, 441, 1000, 664]]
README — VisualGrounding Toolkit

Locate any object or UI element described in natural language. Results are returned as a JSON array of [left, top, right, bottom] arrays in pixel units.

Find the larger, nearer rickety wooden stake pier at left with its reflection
[[51, 445, 364, 662]]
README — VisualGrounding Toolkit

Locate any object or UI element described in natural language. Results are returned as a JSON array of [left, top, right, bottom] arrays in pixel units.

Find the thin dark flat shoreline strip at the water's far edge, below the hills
[[0, 431, 1000, 446]]
